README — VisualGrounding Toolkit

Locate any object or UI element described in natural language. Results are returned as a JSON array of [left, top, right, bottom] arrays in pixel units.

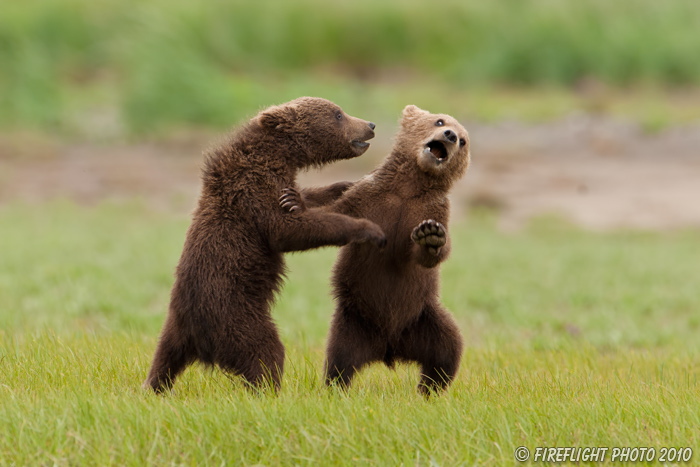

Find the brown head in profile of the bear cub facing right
[[258, 97, 375, 167]]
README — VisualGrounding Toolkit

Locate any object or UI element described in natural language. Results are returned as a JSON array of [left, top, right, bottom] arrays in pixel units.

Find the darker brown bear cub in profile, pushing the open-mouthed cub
[[144, 97, 385, 392]]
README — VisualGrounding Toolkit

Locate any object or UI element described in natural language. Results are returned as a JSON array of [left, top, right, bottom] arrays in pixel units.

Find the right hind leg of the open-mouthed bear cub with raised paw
[[395, 305, 463, 396]]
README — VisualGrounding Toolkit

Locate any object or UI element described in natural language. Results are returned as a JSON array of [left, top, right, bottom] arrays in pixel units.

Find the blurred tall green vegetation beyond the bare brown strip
[[0, 0, 700, 134]]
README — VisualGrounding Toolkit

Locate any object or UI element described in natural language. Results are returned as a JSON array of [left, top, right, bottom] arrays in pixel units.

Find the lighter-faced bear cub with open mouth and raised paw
[[290, 106, 469, 394]]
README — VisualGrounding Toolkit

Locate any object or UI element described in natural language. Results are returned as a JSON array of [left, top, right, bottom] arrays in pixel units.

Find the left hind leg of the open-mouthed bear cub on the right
[[325, 309, 387, 389]]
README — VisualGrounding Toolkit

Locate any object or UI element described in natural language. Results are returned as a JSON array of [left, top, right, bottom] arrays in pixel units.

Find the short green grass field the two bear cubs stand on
[[0, 202, 700, 465]]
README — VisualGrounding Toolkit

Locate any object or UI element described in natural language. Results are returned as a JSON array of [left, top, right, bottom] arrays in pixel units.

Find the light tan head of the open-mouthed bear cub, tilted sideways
[[397, 105, 470, 180]]
